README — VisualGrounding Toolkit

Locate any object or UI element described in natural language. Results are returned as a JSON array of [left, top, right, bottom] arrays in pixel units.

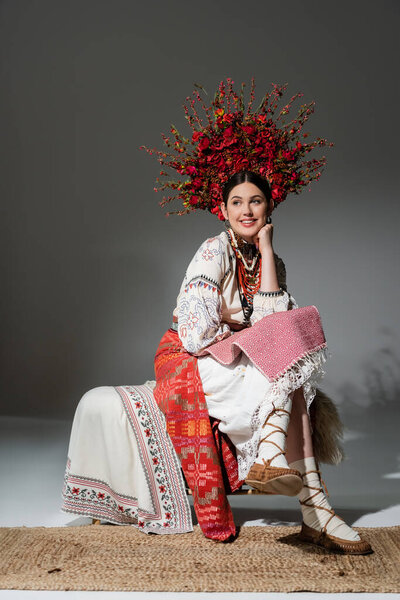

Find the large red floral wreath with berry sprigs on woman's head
[[140, 78, 333, 220]]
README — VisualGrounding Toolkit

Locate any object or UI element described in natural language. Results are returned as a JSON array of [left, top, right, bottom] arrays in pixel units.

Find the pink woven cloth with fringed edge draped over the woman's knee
[[204, 306, 326, 381]]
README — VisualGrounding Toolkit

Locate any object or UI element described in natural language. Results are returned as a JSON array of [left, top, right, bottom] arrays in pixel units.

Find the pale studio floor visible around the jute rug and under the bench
[[0, 417, 400, 600]]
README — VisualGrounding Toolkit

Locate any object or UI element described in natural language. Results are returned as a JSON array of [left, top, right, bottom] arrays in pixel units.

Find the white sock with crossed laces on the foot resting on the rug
[[290, 456, 361, 542]]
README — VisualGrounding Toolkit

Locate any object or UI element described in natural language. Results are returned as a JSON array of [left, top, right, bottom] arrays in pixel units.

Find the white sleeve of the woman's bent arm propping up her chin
[[250, 254, 299, 325]]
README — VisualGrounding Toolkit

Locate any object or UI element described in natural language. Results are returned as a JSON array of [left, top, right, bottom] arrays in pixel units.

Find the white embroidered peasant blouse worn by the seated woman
[[173, 231, 298, 355]]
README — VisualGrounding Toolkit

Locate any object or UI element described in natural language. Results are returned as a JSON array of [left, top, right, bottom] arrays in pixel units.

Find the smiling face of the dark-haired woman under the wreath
[[221, 181, 272, 243]]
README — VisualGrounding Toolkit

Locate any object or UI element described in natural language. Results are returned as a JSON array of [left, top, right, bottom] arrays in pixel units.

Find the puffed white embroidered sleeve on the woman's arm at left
[[177, 236, 231, 354]]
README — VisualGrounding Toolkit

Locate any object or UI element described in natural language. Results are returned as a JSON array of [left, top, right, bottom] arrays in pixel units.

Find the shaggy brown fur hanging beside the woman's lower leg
[[310, 388, 345, 465]]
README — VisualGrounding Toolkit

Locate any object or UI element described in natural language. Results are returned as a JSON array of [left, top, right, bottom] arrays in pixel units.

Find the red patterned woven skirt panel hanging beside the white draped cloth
[[154, 329, 243, 541]]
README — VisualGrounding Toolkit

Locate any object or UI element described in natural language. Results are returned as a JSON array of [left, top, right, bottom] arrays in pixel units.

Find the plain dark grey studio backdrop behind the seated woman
[[0, 0, 400, 422]]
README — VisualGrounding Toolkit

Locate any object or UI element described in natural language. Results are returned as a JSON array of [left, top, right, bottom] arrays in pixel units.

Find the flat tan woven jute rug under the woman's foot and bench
[[0, 525, 400, 592]]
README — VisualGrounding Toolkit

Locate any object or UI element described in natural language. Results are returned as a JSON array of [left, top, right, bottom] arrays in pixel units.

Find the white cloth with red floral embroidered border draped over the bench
[[62, 382, 193, 533]]
